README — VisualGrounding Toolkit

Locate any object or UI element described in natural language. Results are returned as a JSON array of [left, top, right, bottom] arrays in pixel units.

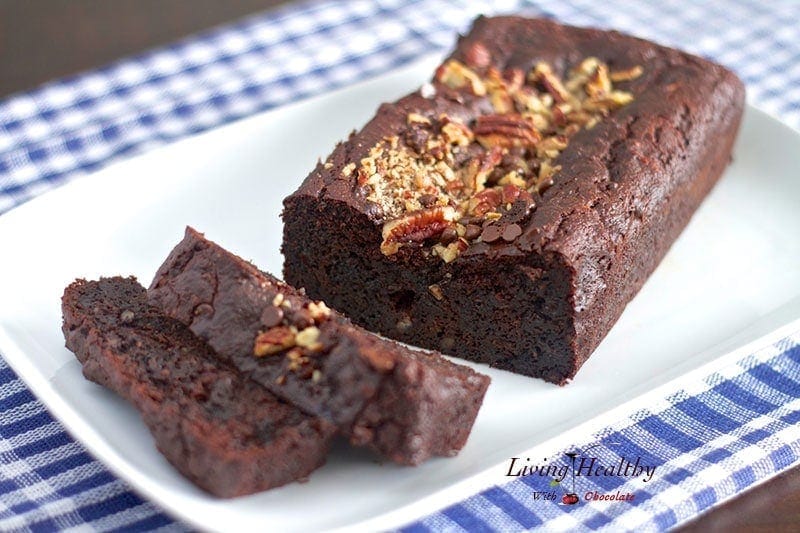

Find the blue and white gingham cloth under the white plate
[[0, 0, 800, 531]]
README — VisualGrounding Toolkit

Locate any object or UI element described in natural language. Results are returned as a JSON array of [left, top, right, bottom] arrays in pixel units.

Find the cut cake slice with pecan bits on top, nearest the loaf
[[148, 228, 489, 465]]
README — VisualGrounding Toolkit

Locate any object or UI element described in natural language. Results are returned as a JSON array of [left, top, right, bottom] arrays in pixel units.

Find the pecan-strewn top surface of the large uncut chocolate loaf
[[296, 17, 740, 262]]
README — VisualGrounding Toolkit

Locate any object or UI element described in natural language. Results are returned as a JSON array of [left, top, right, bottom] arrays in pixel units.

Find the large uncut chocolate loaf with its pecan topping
[[283, 17, 744, 384]]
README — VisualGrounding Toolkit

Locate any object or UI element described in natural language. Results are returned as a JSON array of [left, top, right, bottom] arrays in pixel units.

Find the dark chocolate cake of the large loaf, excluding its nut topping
[[282, 17, 744, 384]]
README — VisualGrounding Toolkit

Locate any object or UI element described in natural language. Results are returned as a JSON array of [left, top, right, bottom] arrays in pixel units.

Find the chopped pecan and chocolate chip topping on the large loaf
[[356, 56, 643, 263]]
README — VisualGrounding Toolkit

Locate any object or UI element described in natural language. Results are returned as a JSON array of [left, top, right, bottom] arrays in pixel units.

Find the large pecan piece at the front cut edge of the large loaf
[[381, 206, 457, 255]]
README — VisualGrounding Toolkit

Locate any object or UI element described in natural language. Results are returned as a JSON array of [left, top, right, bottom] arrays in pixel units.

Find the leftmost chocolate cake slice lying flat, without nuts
[[62, 278, 335, 498]]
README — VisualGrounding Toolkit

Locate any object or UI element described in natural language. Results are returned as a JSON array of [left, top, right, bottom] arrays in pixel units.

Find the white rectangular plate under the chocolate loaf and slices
[[0, 58, 800, 530]]
